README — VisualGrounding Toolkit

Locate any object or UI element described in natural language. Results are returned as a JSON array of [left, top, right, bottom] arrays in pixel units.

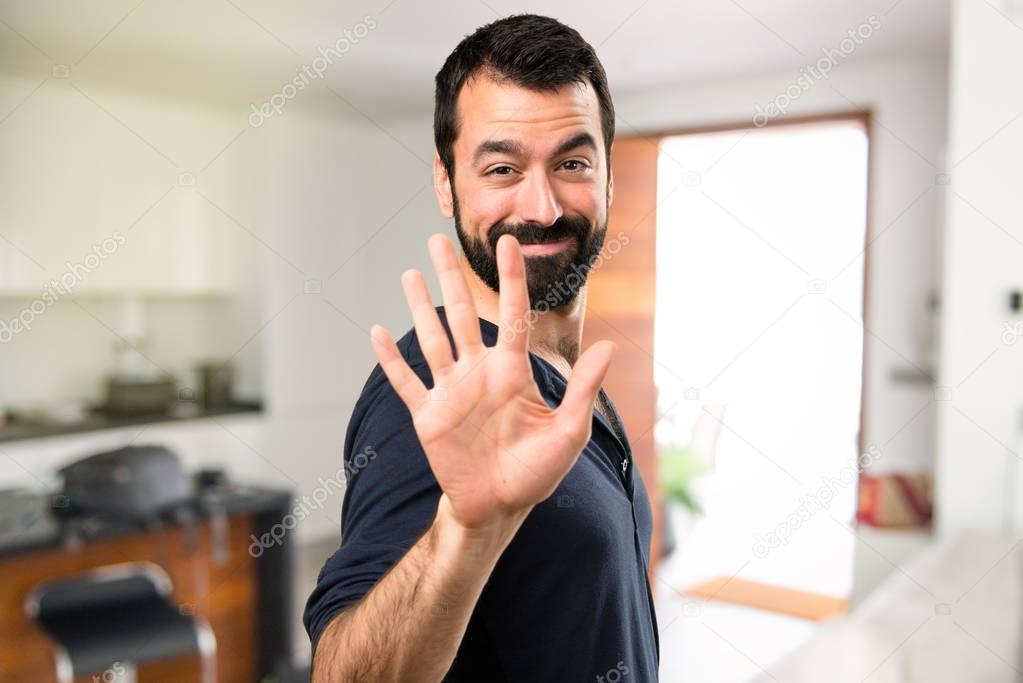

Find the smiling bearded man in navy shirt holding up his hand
[[304, 15, 659, 683]]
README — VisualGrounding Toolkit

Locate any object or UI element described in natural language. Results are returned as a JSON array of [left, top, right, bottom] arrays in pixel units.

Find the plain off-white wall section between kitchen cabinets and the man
[[235, 109, 450, 538]]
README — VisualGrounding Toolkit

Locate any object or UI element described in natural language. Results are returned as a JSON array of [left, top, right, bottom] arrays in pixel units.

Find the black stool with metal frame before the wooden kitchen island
[[26, 562, 217, 683]]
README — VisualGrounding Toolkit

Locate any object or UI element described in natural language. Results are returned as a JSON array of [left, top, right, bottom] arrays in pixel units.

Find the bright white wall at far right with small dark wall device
[[937, 0, 1023, 533]]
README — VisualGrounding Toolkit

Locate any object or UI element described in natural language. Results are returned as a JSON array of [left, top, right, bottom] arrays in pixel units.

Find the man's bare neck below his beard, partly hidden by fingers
[[458, 249, 586, 368]]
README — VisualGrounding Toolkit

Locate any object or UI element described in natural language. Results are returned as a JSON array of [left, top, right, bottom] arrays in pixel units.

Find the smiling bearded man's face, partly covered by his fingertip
[[435, 77, 611, 310]]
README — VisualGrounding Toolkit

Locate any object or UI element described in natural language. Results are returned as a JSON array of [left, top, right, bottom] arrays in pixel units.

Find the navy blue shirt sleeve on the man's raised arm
[[303, 365, 441, 651]]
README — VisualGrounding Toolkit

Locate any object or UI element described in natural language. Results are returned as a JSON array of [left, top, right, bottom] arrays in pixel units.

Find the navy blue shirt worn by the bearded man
[[303, 307, 660, 683]]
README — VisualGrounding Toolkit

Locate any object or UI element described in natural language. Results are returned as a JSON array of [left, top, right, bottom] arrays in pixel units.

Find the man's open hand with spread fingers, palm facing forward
[[373, 237, 613, 527]]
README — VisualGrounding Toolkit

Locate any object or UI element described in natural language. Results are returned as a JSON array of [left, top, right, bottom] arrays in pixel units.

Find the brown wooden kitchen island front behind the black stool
[[0, 490, 292, 683]]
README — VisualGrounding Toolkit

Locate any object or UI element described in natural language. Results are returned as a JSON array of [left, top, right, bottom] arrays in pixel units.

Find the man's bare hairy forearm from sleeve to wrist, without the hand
[[312, 496, 528, 683]]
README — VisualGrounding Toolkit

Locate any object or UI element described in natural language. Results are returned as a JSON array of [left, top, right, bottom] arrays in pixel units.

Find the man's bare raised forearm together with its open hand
[[313, 235, 615, 683]]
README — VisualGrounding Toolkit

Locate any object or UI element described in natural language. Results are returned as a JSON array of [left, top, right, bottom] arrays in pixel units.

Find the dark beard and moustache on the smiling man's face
[[451, 192, 608, 313]]
